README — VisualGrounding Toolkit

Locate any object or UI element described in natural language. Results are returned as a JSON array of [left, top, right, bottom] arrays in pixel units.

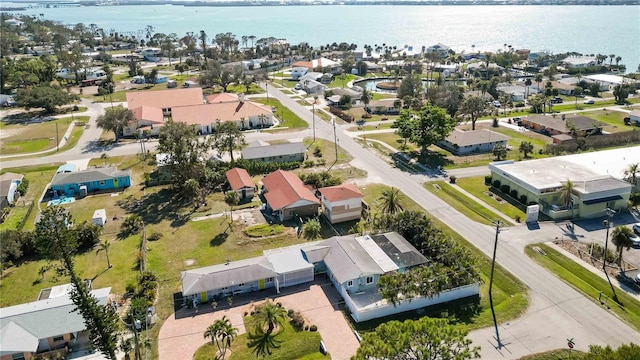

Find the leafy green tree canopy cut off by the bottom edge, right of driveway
[[355, 317, 480, 360]]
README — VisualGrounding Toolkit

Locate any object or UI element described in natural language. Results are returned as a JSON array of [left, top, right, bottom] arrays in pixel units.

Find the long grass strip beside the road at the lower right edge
[[525, 244, 640, 330]]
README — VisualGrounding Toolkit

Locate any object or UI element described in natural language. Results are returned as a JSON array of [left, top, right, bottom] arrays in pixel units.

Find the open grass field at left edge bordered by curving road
[[0, 116, 89, 155]]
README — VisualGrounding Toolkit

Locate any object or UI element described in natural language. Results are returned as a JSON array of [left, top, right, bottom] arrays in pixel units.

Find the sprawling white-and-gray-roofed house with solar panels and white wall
[[181, 232, 480, 322]]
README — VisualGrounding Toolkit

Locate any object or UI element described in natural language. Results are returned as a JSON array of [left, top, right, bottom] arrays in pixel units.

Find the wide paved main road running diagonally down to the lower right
[[269, 83, 640, 359]]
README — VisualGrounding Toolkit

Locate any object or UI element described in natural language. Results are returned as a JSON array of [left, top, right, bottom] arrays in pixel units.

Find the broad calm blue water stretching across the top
[[16, 5, 640, 71]]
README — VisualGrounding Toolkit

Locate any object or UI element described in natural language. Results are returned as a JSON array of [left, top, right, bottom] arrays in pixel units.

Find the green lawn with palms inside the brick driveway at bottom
[[193, 316, 331, 360]]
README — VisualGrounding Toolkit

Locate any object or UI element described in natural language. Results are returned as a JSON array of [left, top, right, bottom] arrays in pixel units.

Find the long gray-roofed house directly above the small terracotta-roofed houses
[[241, 140, 307, 162]]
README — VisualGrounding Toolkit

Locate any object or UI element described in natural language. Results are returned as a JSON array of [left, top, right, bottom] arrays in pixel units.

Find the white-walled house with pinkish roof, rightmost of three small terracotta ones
[[318, 184, 364, 224]]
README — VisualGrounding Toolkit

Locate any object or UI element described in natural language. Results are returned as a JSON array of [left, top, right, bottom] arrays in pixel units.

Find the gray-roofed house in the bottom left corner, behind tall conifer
[[0, 287, 111, 352]]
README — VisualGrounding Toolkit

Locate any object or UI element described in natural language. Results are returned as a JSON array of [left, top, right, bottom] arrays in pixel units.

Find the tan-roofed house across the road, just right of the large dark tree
[[438, 129, 509, 155]]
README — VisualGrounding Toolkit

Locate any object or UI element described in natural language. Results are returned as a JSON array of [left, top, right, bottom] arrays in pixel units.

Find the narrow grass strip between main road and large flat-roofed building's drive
[[424, 181, 502, 225]]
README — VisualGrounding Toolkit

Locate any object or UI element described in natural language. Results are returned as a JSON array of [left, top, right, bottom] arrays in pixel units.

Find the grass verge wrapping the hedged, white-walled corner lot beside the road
[[356, 184, 529, 331]]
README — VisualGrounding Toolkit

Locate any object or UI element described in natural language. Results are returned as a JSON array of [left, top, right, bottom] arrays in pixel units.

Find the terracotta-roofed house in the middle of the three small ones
[[262, 170, 320, 221]]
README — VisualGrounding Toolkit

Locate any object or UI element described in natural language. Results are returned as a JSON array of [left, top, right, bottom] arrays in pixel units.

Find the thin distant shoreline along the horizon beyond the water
[[0, 0, 640, 12]]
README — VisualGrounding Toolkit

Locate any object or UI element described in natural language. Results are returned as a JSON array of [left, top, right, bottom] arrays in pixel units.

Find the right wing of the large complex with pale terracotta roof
[[172, 96, 274, 134]]
